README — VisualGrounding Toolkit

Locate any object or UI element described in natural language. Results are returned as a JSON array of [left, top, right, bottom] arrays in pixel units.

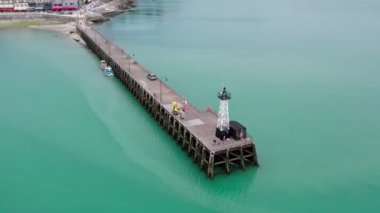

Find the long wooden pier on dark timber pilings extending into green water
[[77, 22, 258, 178]]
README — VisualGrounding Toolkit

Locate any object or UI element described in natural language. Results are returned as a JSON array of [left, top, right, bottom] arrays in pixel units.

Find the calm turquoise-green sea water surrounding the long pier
[[0, 0, 380, 213]]
